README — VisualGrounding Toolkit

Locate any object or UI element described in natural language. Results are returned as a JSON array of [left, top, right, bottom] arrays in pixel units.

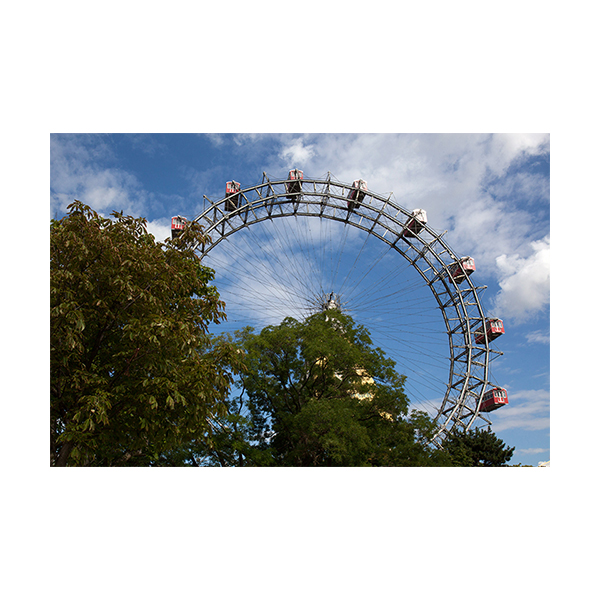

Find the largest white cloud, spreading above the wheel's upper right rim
[[267, 134, 549, 276]]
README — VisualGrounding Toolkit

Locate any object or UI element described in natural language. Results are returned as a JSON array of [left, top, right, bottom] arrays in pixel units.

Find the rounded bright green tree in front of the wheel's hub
[[205, 310, 446, 466]]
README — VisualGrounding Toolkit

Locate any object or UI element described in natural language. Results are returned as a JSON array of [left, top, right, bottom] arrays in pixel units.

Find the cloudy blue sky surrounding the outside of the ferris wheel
[[50, 133, 550, 465]]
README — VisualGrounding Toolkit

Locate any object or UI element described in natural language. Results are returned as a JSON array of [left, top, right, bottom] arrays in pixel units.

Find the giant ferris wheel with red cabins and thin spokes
[[182, 169, 508, 446]]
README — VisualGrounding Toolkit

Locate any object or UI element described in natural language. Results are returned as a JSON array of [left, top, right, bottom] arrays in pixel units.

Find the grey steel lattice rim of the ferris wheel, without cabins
[[194, 174, 499, 446]]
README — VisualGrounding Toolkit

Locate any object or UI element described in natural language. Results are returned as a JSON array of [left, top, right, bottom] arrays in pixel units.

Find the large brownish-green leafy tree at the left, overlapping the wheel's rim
[[50, 201, 239, 466]]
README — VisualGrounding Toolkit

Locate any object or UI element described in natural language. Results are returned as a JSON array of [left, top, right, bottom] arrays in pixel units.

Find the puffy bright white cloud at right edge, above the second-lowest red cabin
[[495, 236, 550, 322]]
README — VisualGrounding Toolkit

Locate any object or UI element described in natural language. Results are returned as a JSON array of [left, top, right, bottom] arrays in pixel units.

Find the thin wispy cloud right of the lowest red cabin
[[491, 390, 550, 433]]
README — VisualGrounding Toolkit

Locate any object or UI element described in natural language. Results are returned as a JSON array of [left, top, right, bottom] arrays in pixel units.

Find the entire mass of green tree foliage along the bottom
[[50, 201, 514, 466]]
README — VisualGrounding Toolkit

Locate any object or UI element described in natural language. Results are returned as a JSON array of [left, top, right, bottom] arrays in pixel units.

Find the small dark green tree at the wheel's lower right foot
[[444, 428, 515, 467]]
